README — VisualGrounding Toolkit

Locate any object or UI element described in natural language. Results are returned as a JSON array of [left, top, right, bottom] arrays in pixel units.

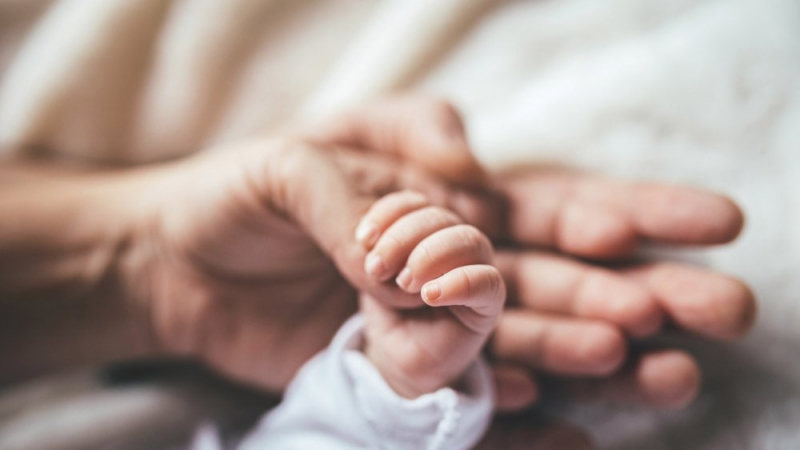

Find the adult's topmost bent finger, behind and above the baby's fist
[[306, 97, 486, 185]]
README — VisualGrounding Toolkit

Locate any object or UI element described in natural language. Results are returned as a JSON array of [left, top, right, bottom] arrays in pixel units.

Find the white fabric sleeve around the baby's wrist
[[239, 315, 494, 450]]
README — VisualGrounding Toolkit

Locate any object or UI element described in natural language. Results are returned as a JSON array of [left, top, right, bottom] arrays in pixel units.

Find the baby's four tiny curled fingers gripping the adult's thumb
[[356, 191, 506, 333]]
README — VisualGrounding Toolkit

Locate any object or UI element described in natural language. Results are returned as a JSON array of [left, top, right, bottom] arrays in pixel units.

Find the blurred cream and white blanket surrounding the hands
[[0, 0, 800, 450]]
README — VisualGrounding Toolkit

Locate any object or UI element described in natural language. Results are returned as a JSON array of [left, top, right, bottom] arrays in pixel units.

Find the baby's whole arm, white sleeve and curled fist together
[[234, 192, 505, 450]]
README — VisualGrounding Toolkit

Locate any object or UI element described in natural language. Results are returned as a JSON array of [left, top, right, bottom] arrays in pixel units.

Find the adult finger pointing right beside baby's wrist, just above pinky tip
[[489, 309, 627, 376]]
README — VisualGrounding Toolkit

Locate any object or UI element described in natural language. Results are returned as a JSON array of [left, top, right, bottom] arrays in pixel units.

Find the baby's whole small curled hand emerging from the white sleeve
[[356, 191, 506, 398]]
